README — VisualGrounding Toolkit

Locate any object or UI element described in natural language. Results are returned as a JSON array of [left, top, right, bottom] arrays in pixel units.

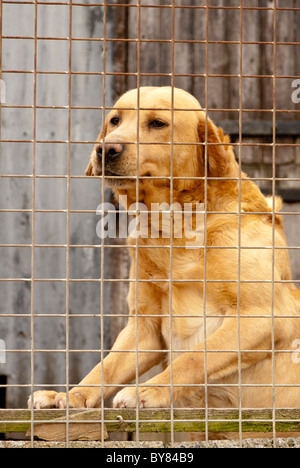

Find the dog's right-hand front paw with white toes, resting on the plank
[[113, 387, 171, 408]]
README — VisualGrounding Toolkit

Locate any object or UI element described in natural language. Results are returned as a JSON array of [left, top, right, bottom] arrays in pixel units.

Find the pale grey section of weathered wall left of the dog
[[0, 4, 114, 407]]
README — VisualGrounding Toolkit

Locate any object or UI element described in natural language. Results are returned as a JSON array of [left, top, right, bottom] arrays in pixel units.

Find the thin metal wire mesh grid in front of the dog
[[0, 0, 300, 446]]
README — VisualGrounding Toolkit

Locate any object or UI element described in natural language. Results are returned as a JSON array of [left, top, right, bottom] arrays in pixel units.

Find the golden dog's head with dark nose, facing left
[[86, 87, 234, 196]]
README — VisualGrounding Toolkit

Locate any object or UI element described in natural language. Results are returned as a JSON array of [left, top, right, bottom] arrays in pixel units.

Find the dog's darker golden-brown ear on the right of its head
[[198, 114, 230, 177]]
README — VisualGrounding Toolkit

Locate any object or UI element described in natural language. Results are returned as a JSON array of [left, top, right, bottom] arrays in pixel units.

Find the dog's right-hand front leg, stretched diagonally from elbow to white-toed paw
[[114, 310, 272, 408]]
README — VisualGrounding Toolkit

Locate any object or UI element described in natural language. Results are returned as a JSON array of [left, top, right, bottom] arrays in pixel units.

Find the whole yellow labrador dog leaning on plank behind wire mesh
[[29, 87, 300, 416]]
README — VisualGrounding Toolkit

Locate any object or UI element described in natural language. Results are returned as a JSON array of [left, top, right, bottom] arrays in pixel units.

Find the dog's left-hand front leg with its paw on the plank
[[28, 317, 162, 409]]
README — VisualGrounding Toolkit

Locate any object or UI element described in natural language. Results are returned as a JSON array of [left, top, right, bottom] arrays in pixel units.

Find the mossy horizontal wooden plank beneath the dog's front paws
[[0, 409, 300, 440]]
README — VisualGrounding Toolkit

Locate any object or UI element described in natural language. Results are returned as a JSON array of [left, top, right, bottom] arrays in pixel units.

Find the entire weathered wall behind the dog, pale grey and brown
[[0, 0, 300, 407]]
